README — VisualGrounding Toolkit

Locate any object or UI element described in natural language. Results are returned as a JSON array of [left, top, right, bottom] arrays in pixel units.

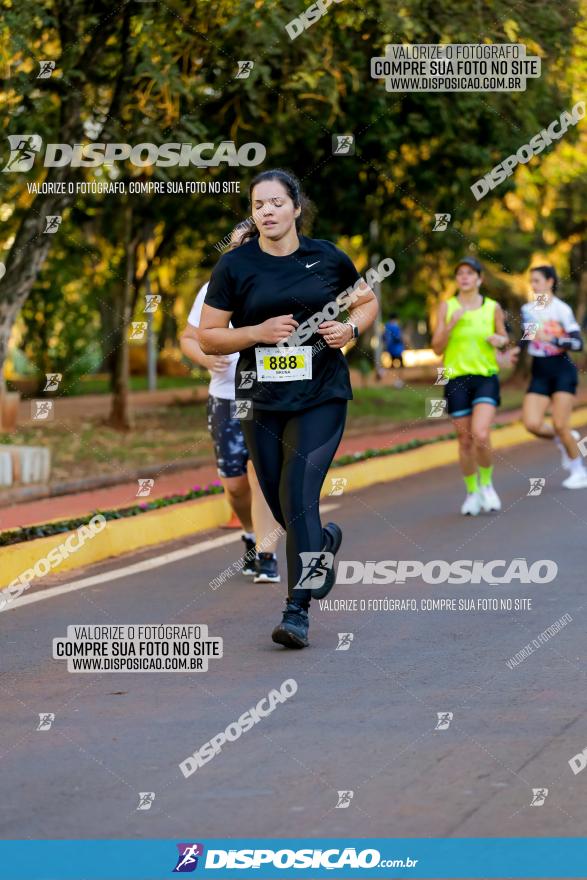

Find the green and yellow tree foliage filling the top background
[[0, 0, 587, 420]]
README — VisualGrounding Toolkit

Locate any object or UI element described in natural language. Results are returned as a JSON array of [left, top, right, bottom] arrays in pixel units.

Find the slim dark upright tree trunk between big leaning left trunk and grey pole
[[108, 204, 136, 431]]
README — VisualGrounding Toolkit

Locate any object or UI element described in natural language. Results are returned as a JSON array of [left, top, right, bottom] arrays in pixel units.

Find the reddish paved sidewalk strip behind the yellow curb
[[0, 410, 520, 531]]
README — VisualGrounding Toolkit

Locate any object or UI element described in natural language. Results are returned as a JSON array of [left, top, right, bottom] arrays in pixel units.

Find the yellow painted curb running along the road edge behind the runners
[[0, 408, 587, 587]]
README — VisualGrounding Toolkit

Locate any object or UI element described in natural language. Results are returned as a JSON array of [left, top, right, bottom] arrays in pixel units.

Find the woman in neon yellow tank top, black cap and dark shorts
[[432, 257, 508, 516]]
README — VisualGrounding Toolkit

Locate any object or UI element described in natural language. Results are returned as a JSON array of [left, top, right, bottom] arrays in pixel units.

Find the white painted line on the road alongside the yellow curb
[[2, 504, 339, 614]]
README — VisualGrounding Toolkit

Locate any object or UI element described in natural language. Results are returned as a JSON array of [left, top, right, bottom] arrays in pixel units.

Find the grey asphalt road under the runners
[[0, 443, 587, 840]]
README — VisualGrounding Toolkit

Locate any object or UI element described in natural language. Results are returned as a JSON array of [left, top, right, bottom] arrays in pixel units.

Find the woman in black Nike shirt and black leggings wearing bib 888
[[199, 170, 377, 648]]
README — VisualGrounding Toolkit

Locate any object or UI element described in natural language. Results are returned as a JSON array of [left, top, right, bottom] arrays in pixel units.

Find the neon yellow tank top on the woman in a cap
[[444, 296, 499, 379]]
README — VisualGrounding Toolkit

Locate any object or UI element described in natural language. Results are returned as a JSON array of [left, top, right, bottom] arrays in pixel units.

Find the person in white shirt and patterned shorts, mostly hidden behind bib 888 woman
[[180, 224, 281, 583]]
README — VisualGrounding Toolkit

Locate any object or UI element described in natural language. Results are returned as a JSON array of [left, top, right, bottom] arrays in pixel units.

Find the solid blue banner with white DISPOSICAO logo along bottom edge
[[0, 837, 587, 880]]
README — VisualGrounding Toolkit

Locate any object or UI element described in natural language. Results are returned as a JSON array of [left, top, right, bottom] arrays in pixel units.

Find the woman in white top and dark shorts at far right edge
[[521, 266, 587, 489]]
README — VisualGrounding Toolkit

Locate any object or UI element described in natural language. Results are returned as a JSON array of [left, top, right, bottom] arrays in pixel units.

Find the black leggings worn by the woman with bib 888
[[241, 399, 347, 605]]
